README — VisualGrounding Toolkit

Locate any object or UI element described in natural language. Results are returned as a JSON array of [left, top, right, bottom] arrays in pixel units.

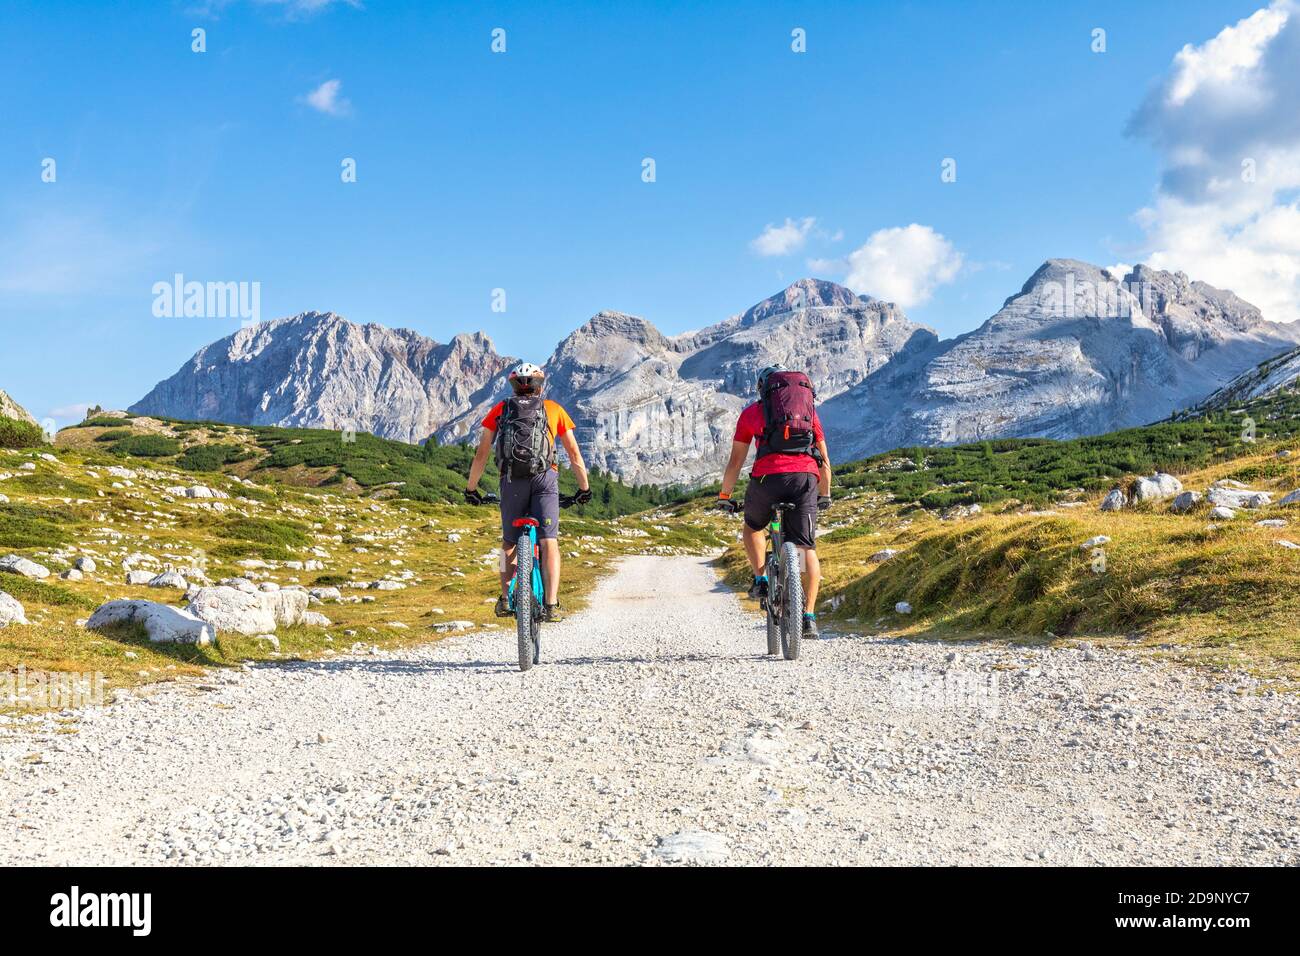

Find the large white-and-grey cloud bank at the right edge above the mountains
[[1130, 0, 1300, 321]]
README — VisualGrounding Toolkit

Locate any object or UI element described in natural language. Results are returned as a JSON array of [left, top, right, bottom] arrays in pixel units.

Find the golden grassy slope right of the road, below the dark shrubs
[[724, 442, 1300, 679]]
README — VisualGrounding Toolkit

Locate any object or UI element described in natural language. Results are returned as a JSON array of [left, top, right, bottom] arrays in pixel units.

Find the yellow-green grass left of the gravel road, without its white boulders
[[0, 429, 720, 710]]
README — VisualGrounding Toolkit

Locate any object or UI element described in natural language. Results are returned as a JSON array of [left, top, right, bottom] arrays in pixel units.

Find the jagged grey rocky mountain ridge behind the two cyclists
[[131, 259, 1300, 485]]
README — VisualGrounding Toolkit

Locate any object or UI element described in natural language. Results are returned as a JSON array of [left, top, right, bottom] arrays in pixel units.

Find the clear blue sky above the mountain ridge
[[0, 0, 1295, 424]]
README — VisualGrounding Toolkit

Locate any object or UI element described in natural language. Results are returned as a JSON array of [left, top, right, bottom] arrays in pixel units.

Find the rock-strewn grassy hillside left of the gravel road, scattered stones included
[[0, 431, 722, 710]]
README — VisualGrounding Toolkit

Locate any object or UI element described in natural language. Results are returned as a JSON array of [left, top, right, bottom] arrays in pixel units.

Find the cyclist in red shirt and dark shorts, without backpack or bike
[[718, 365, 831, 639]]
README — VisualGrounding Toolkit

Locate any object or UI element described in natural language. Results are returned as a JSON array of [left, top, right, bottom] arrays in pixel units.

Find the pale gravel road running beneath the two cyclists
[[0, 557, 1300, 865]]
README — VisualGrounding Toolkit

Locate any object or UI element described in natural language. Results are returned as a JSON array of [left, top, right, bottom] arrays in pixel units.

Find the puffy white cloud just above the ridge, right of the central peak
[[832, 222, 962, 308]]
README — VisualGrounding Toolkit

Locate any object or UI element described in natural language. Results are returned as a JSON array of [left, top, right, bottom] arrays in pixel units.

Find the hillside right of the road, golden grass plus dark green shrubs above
[[724, 390, 1300, 682]]
